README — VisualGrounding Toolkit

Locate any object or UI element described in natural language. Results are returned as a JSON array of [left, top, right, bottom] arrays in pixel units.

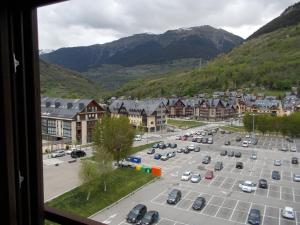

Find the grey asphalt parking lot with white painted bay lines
[[91, 127, 300, 225]]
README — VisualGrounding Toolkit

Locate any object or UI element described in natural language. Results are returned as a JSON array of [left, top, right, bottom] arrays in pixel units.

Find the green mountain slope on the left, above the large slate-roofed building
[[40, 60, 101, 98]]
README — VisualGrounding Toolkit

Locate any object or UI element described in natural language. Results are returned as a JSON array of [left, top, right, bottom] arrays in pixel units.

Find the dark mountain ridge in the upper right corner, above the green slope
[[248, 2, 300, 39]]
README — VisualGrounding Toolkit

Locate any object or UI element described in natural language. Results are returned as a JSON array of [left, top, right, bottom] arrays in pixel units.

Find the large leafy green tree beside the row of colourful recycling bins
[[94, 116, 135, 165]]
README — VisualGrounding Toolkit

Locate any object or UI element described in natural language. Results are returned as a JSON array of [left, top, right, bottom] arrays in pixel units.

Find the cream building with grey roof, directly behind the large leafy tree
[[109, 99, 168, 132]]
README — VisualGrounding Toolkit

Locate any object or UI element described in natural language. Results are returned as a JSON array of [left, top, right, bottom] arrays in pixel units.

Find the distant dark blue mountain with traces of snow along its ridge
[[41, 25, 243, 72]]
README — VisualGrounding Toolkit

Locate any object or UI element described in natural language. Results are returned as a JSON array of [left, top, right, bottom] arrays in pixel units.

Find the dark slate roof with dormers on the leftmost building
[[41, 97, 93, 119]]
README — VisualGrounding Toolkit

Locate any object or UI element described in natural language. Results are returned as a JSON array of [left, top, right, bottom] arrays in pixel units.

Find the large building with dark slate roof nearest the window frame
[[41, 97, 105, 144]]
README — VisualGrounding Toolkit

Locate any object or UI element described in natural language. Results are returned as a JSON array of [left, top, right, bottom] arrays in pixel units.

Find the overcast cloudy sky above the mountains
[[38, 0, 299, 49]]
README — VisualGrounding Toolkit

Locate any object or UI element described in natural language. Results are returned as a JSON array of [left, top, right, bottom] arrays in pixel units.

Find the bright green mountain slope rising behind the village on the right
[[115, 23, 300, 97]]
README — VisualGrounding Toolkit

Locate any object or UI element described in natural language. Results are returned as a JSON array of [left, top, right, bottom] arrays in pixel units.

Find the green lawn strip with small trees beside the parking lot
[[47, 168, 155, 217]]
